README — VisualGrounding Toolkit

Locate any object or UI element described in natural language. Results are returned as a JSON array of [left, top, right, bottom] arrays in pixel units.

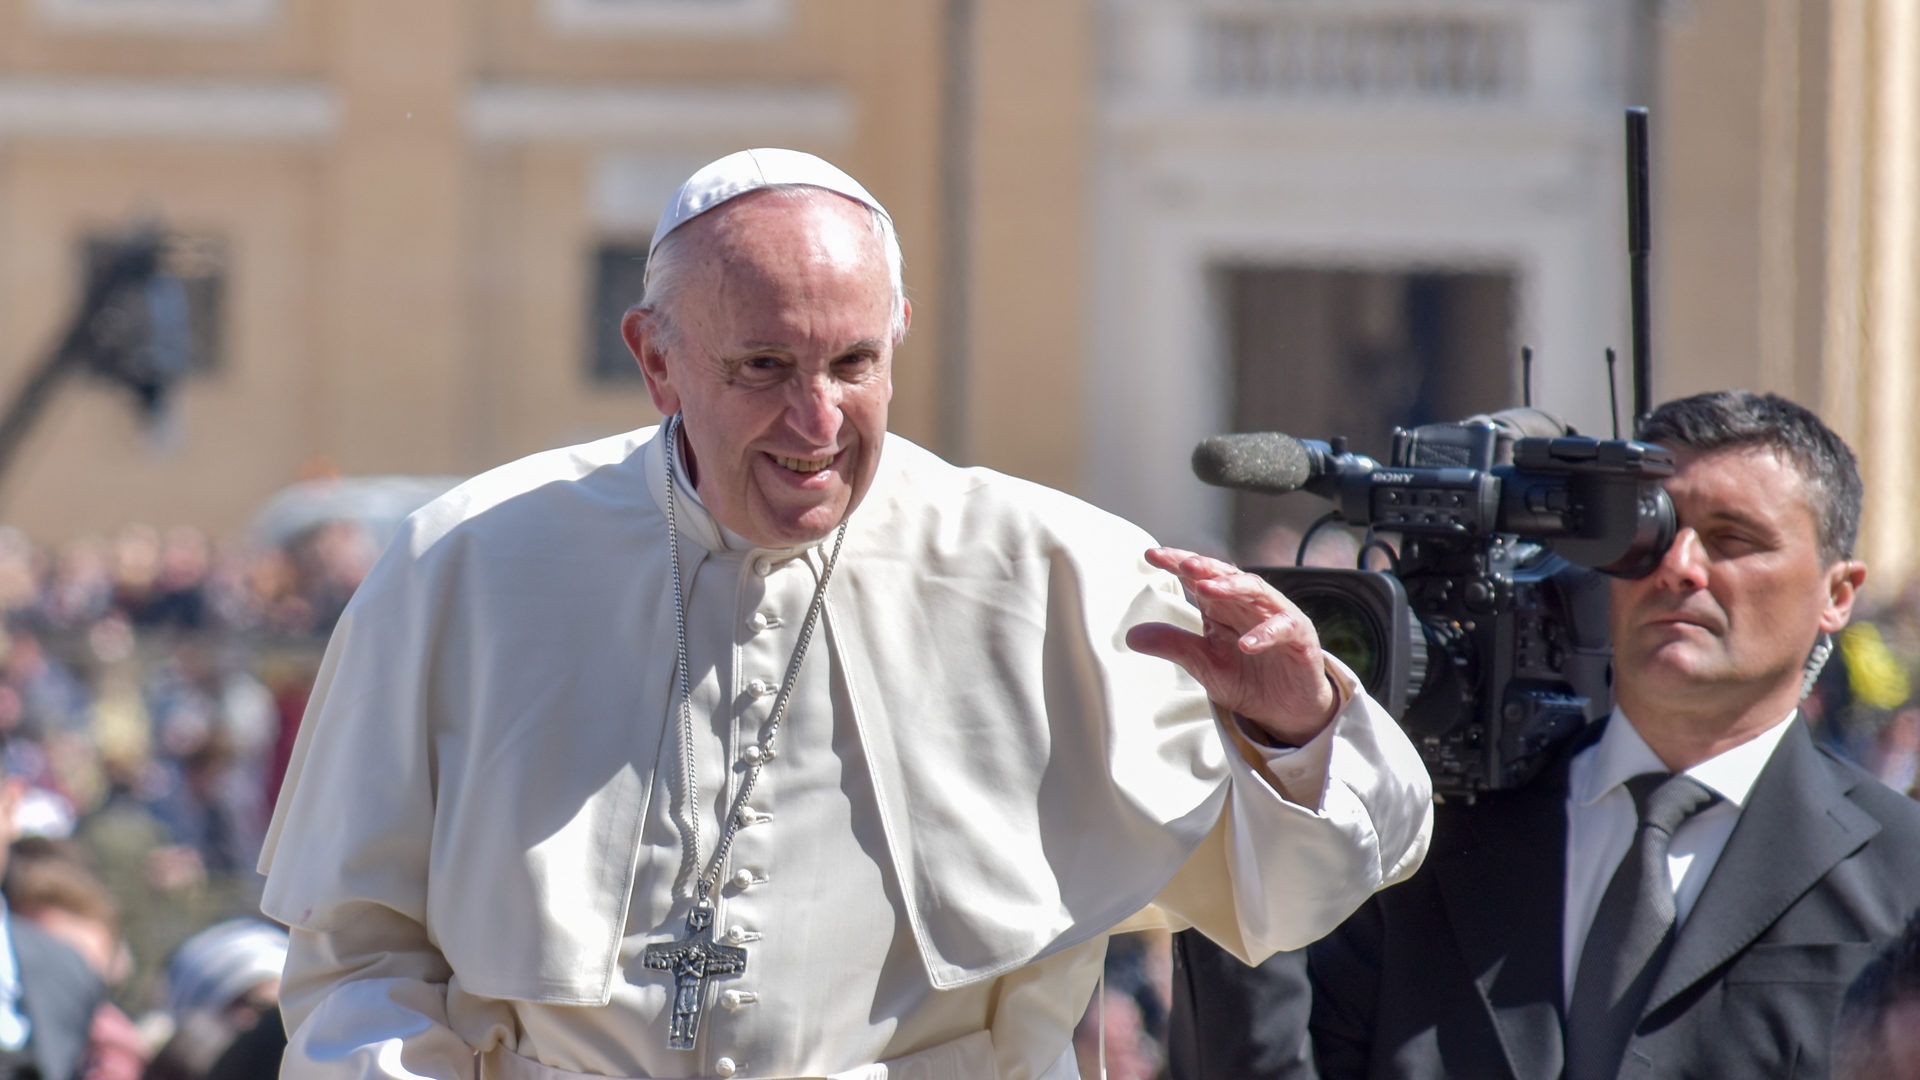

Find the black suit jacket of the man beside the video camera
[[1175, 721, 1920, 1080]]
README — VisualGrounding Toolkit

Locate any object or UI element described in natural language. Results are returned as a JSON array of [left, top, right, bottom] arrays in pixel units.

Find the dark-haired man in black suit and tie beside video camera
[[1173, 390, 1920, 1080]]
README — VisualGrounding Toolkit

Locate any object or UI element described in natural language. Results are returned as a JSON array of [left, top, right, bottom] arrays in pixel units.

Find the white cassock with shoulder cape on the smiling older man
[[261, 429, 1430, 1080]]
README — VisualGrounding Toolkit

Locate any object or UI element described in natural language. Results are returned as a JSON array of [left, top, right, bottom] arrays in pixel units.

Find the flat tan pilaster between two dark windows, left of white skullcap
[[311, 0, 474, 473]]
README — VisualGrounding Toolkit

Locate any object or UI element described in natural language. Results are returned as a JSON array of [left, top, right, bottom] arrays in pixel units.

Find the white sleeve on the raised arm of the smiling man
[[1156, 657, 1432, 965]]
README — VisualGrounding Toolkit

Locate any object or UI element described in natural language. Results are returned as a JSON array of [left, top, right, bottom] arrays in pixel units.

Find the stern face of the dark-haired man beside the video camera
[[1613, 448, 1862, 717]]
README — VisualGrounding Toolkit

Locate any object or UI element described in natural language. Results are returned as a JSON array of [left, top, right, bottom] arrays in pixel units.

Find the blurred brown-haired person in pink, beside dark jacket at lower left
[[6, 836, 154, 1080]]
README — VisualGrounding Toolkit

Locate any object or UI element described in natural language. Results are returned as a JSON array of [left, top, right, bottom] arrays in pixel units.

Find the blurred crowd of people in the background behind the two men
[[11, 521, 1920, 1080]]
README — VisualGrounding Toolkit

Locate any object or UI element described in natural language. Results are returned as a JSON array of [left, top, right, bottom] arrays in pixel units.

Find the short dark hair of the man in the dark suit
[[1638, 390, 1860, 563]]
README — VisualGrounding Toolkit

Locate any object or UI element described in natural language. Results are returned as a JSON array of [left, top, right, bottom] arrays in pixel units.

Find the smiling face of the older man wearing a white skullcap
[[626, 192, 893, 548]]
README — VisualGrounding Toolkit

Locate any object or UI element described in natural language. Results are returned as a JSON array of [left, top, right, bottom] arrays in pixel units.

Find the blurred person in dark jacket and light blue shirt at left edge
[[0, 757, 106, 1080]]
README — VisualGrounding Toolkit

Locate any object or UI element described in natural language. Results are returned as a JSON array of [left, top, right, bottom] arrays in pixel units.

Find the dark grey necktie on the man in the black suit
[[1567, 773, 1720, 1080]]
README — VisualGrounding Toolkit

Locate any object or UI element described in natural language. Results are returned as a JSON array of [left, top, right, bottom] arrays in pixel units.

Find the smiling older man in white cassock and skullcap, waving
[[261, 150, 1430, 1080]]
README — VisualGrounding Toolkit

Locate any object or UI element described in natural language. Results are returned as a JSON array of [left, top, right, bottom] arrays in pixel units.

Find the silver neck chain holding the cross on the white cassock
[[666, 413, 847, 905]]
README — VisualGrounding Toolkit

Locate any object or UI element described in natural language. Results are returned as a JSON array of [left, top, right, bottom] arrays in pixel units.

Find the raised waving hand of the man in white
[[1127, 548, 1340, 746]]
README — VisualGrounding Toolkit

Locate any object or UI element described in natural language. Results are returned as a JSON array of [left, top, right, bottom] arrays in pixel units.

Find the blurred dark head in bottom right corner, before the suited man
[[1834, 911, 1920, 1080]]
